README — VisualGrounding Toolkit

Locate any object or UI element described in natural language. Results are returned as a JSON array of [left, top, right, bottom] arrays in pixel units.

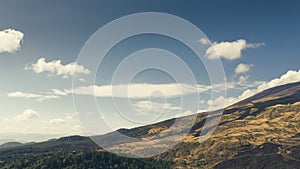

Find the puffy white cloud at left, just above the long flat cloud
[[25, 58, 90, 78]]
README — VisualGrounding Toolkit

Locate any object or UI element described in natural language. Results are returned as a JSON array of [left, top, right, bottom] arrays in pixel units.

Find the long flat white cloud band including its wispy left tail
[[7, 83, 225, 102]]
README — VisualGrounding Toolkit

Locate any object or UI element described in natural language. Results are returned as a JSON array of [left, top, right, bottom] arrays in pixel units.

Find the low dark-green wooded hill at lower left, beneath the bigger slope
[[0, 136, 173, 169]]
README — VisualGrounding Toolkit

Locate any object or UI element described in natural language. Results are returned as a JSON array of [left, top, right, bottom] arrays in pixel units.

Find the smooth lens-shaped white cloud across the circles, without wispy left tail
[[73, 83, 205, 98]]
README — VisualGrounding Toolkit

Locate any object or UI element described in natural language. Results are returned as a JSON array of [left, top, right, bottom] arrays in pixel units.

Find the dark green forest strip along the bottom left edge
[[0, 152, 172, 169]]
